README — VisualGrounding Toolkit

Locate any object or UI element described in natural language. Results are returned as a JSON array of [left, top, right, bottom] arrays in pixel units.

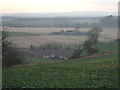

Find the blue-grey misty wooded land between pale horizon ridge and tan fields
[[2, 13, 118, 28]]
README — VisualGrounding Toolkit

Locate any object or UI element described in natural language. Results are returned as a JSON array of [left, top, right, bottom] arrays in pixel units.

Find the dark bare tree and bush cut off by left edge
[[2, 28, 23, 67]]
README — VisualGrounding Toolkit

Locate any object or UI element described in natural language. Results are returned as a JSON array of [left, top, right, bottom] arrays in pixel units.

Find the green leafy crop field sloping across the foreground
[[2, 42, 118, 88]]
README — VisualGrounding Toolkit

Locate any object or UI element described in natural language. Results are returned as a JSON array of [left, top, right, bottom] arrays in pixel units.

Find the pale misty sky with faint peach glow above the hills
[[0, 0, 119, 13]]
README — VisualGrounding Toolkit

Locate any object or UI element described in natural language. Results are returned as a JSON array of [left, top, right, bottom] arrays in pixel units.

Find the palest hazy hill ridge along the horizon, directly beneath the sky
[[2, 11, 117, 17]]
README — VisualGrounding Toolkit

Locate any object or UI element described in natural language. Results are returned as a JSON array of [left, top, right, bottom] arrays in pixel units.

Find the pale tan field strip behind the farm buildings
[[8, 27, 118, 37]]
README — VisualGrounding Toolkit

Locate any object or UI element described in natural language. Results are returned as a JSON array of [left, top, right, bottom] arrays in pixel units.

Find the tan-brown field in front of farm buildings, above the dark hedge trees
[[10, 35, 86, 47]]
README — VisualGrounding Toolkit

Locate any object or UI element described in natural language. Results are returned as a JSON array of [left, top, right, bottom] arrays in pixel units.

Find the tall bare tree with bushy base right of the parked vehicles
[[72, 27, 102, 58]]
